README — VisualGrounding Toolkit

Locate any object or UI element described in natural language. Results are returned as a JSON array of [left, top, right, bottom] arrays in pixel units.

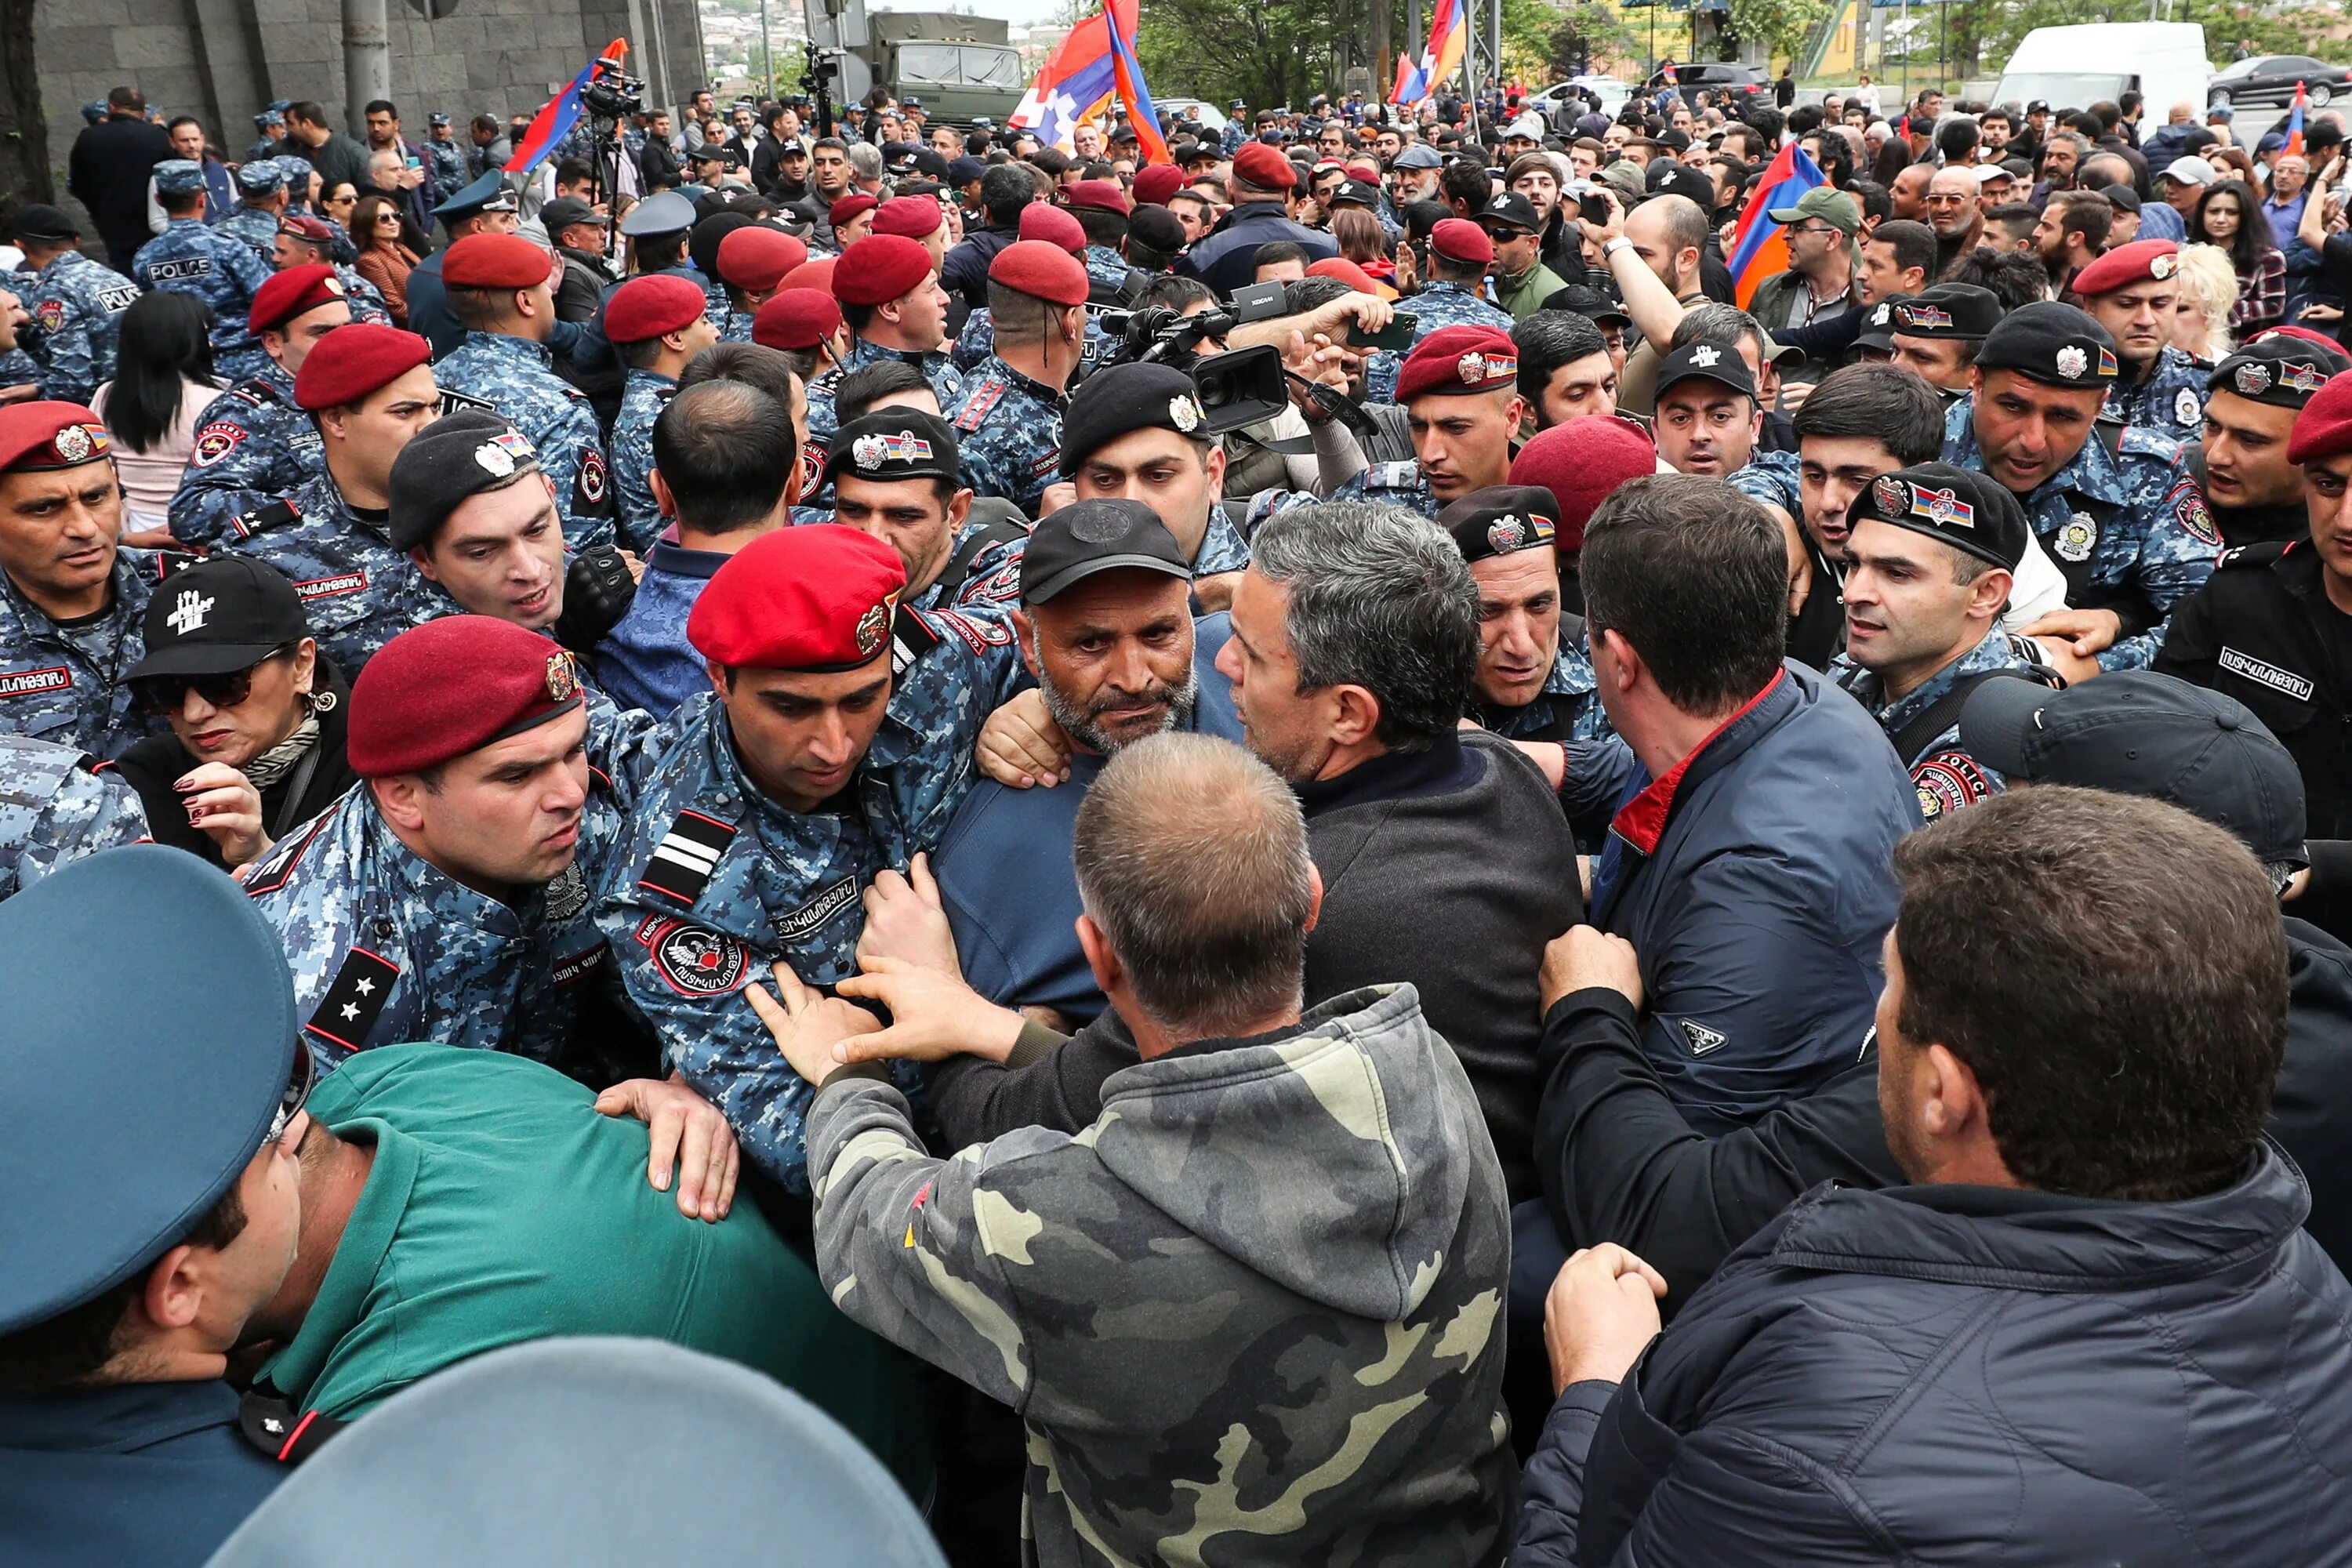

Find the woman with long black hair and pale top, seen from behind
[[89, 289, 221, 548]]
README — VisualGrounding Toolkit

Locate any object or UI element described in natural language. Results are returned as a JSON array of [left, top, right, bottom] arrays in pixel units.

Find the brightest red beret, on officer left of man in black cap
[[687, 522, 906, 670]]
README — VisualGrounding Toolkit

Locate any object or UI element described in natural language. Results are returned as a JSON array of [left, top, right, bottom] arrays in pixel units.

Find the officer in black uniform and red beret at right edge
[[2154, 368, 2352, 839]]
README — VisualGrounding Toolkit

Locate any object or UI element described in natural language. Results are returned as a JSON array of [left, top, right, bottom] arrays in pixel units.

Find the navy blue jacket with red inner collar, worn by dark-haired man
[[1592, 663, 1919, 1135]]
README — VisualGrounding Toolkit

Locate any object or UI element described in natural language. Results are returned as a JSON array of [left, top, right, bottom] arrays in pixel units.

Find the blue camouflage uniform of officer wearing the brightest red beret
[[597, 612, 1021, 1192]]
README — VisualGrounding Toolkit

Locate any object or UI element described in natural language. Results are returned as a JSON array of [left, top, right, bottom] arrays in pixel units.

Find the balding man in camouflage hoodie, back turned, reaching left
[[746, 733, 1517, 1568]]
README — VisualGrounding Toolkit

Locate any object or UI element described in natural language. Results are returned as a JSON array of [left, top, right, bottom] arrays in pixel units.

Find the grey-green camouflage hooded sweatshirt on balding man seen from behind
[[809, 985, 1517, 1568]]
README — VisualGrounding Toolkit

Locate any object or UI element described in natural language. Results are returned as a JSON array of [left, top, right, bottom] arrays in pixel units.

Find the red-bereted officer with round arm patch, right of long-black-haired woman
[[169, 266, 350, 548]]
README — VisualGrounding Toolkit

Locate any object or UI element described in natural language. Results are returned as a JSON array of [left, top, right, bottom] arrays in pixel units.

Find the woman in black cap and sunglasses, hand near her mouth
[[111, 555, 358, 869]]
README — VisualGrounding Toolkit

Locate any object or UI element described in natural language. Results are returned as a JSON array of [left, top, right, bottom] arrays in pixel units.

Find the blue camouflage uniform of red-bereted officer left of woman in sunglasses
[[0, 550, 162, 760]]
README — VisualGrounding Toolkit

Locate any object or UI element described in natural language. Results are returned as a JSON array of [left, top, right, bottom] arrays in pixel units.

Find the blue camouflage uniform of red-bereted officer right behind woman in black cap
[[221, 470, 454, 680]]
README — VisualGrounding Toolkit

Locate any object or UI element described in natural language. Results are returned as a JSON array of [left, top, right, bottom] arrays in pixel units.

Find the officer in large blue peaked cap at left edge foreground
[[0, 844, 310, 1568]]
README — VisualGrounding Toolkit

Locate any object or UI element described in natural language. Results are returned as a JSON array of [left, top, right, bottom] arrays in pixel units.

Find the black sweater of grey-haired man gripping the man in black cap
[[931, 731, 1583, 1201]]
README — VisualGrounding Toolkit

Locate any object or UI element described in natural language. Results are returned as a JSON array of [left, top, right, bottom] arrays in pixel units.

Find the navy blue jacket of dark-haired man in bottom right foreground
[[1510, 1145, 2352, 1568]]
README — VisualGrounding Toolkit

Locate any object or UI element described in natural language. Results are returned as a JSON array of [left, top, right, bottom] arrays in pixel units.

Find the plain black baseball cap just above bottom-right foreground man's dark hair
[[1959, 670, 2310, 865]]
